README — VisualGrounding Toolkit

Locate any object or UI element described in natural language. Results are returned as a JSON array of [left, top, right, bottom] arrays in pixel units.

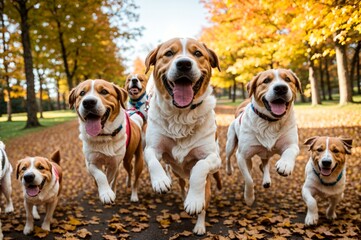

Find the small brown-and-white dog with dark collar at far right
[[302, 136, 352, 226]]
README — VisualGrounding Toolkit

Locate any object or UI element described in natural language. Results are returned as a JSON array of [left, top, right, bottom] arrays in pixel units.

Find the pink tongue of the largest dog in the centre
[[173, 81, 193, 107]]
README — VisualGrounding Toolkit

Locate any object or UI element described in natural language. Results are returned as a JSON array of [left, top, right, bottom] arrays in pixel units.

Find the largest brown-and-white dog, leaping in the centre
[[144, 38, 221, 235]]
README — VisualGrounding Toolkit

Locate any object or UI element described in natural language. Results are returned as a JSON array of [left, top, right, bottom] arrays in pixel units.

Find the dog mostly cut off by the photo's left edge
[[0, 141, 14, 239]]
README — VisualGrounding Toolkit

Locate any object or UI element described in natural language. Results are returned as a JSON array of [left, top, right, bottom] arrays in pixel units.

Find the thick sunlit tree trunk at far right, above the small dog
[[335, 42, 352, 105]]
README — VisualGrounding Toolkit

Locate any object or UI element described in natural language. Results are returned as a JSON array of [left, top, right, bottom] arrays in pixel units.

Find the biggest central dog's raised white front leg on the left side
[[144, 147, 171, 193]]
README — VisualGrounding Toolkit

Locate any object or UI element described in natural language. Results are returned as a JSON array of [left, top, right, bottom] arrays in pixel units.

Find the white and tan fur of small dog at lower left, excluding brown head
[[21, 158, 60, 235]]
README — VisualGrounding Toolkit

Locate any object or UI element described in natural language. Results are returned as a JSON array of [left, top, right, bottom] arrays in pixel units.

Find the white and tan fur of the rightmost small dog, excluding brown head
[[302, 146, 346, 226]]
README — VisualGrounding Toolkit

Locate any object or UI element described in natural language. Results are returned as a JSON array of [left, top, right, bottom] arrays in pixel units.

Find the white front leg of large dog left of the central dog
[[88, 163, 115, 204]]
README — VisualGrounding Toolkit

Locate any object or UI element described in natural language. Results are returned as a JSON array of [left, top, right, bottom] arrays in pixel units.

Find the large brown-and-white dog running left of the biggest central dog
[[69, 79, 144, 204]]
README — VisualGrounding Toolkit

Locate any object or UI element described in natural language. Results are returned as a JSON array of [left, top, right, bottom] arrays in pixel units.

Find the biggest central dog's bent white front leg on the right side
[[184, 153, 221, 215]]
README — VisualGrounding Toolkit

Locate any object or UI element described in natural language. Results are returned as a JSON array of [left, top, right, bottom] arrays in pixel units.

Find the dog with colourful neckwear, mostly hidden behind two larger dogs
[[125, 74, 148, 125]]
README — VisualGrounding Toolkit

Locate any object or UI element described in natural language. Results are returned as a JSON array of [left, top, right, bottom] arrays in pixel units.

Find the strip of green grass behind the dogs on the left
[[0, 110, 76, 142]]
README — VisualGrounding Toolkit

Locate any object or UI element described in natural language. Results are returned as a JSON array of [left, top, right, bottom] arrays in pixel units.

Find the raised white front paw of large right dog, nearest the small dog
[[276, 144, 300, 177]]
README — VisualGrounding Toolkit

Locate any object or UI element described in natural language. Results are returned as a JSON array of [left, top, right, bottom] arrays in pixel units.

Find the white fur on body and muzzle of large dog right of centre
[[226, 78, 299, 206]]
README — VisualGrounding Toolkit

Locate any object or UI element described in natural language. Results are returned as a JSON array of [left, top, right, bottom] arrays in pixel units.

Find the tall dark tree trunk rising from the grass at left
[[16, 0, 40, 128]]
